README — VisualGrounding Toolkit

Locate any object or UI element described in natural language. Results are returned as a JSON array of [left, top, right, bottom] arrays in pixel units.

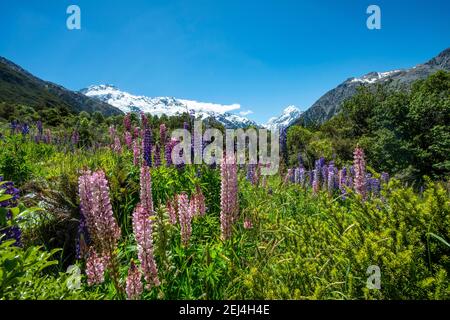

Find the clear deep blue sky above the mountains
[[0, 0, 450, 122]]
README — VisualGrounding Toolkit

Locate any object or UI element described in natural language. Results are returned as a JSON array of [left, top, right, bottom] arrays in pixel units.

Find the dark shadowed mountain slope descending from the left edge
[[0, 57, 121, 116]]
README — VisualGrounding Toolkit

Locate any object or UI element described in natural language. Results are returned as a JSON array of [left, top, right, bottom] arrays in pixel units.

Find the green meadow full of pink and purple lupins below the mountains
[[0, 108, 450, 299]]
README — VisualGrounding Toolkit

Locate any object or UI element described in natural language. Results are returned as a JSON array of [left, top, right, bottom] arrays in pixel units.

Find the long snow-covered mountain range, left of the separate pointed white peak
[[80, 85, 256, 128]]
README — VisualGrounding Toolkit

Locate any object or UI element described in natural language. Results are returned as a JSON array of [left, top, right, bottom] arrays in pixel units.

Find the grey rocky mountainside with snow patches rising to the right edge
[[296, 48, 450, 124]]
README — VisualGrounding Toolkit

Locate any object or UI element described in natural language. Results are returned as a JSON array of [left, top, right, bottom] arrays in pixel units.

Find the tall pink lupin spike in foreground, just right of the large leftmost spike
[[133, 205, 160, 289]]
